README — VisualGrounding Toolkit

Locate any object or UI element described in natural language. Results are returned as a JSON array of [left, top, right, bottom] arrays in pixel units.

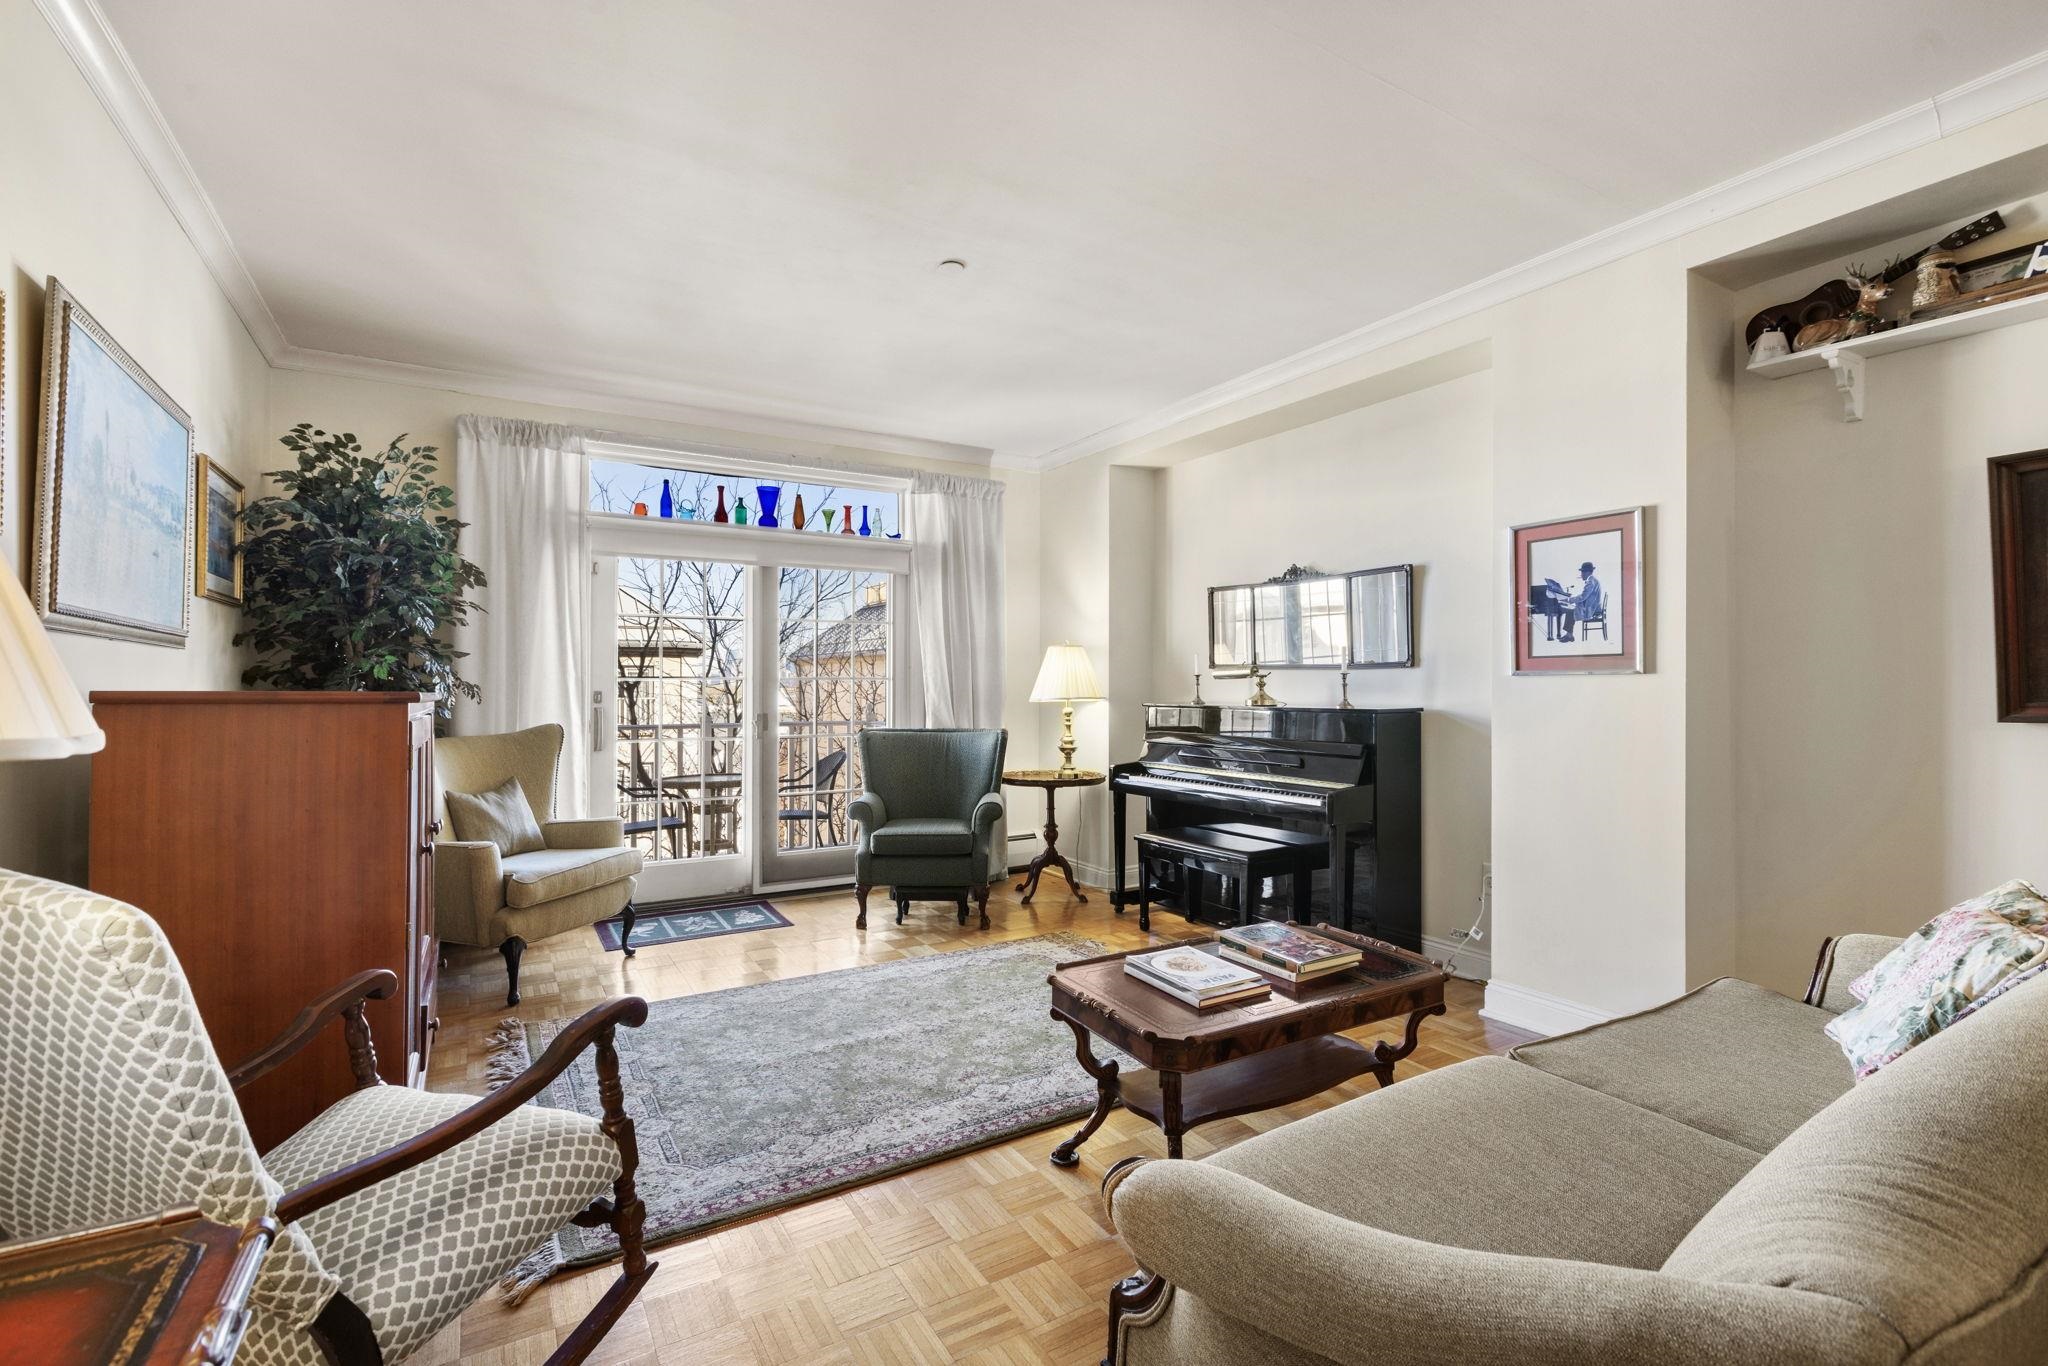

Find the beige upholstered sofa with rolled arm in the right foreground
[[1110, 934, 2048, 1366]]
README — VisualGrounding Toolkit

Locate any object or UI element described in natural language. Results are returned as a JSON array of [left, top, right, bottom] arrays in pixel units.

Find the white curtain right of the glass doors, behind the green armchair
[[903, 473, 1004, 727]]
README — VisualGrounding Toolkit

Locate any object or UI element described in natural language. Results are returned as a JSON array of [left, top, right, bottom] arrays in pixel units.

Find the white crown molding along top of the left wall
[[35, 0, 285, 365]]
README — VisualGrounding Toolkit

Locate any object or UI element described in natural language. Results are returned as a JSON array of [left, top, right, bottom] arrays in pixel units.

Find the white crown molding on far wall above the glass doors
[[270, 346, 991, 467]]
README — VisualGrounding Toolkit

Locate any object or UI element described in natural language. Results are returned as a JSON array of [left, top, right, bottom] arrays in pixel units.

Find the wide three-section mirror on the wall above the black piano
[[1208, 565, 1415, 670]]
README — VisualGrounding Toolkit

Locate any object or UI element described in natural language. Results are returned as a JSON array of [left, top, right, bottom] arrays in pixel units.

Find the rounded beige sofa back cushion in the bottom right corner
[[1663, 979, 2048, 1360]]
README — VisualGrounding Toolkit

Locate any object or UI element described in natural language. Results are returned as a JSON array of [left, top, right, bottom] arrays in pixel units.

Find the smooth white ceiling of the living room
[[100, 0, 2048, 459]]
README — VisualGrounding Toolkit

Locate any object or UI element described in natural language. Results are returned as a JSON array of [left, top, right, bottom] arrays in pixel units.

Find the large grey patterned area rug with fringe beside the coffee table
[[489, 934, 1128, 1300]]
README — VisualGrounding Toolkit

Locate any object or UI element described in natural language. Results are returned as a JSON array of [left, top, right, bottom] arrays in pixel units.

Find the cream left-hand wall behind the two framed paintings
[[0, 0, 268, 881]]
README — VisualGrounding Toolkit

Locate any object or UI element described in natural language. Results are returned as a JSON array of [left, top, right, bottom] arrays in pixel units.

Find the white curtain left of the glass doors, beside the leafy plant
[[455, 416, 590, 817]]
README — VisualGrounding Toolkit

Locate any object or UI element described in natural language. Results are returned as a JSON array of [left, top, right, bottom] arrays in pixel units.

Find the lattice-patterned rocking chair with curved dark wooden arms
[[0, 870, 653, 1366]]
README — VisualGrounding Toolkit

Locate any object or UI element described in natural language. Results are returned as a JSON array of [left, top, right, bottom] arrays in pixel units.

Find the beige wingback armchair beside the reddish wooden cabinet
[[434, 725, 641, 1006]]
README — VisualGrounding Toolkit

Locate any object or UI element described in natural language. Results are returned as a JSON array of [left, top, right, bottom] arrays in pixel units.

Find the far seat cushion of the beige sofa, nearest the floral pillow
[[1507, 977, 1851, 1153]]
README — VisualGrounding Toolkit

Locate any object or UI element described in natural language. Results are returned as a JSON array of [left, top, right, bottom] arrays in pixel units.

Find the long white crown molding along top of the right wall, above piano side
[[1032, 51, 2048, 469]]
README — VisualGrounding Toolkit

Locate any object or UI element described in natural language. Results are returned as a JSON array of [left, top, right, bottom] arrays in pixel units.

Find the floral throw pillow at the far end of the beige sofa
[[1827, 887, 2048, 1081]]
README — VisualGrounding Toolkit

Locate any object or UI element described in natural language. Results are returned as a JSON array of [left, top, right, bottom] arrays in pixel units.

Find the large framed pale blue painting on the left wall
[[35, 276, 193, 649]]
